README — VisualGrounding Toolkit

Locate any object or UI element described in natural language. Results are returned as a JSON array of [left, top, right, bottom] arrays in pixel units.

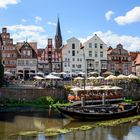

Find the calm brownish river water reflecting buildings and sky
[[0, 111, 140, 140]]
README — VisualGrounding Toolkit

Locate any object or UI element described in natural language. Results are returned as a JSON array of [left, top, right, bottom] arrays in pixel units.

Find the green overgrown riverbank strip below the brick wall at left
[[0, 96, 70, 112]]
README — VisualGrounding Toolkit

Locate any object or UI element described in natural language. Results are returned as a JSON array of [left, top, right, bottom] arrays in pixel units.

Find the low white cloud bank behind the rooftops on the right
[[79, 31, 140, 51]]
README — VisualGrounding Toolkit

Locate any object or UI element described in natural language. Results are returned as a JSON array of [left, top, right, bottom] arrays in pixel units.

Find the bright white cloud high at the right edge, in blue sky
[[115, 7, 140, 25]]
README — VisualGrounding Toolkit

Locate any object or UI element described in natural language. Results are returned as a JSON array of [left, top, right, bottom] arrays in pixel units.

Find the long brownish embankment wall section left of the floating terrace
[[0, 88, 67, 100]]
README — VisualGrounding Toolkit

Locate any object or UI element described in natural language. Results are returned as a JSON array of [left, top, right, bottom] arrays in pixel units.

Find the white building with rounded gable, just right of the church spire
[[62, 37, 85, 74]]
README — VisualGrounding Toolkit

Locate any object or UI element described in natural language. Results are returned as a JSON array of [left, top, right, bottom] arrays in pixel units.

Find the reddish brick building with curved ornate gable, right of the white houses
[[107, 44, 132, 75]]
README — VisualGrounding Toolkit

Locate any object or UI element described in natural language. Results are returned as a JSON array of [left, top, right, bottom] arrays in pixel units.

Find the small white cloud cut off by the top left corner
[[0, 0, 21, 8]]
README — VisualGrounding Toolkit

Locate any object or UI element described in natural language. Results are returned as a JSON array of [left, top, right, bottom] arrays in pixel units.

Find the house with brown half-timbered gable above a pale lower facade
[[16, 42, 37, 79]]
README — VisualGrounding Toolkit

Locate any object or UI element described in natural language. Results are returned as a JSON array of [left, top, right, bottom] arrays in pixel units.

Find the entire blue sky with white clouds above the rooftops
[[0, 0, 140, 51]]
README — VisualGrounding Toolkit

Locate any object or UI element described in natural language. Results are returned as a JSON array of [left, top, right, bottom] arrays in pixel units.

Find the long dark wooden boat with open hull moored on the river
[[57, 103, 137, 121]]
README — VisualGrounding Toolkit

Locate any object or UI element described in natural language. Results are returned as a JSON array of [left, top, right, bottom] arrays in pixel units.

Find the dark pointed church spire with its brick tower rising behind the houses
[[55, 17, 62, 49]]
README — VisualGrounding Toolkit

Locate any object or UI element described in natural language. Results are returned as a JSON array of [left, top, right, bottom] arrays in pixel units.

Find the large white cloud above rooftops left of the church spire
[[7, 25, 48, 48]]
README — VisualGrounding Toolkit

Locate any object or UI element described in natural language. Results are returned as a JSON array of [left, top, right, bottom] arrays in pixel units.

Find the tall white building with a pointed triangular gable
[[83, 34, 107, 73]]
